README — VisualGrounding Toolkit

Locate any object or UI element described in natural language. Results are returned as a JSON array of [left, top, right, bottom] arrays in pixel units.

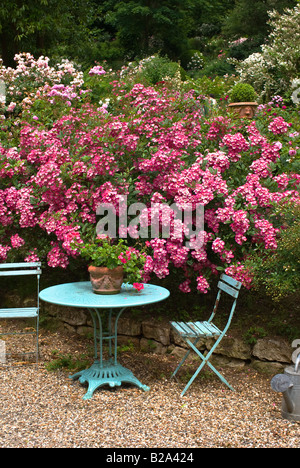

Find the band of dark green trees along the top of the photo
[[0, 0, 297, 70]]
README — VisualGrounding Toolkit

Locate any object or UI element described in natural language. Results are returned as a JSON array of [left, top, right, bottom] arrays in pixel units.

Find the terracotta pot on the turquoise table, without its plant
[[88, 266, 124, 294]]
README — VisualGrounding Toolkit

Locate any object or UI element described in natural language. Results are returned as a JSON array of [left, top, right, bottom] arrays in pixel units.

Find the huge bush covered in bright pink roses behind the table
[[0, 57, 300, 293]]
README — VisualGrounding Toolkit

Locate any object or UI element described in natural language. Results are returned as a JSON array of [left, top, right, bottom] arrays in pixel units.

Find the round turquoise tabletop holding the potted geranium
[[39, 281, 170, 309]]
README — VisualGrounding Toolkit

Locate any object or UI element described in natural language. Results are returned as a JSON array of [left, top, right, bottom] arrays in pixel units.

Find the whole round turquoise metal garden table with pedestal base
[[40, 281, 170, 400]]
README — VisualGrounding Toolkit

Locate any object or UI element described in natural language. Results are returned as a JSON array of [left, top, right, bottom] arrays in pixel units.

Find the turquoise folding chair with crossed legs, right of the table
[[170, 274, 242, 396]]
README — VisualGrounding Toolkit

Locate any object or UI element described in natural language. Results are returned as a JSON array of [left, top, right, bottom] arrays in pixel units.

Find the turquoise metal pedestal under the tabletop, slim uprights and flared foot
[[70, 309, 150, 400]]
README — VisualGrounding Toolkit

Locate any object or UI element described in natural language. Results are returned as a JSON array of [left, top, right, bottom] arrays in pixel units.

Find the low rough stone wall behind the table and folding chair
[[43, 304, 293, 374]]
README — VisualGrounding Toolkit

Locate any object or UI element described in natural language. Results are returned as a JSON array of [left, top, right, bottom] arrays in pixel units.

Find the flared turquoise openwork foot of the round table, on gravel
[[70, 361, 150, 400]]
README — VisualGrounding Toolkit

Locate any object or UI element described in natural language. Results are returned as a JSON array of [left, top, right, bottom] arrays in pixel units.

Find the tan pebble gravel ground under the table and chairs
[[0, 324, 300, 449]]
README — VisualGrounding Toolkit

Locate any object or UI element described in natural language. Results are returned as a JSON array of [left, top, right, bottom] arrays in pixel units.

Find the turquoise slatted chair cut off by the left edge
[[0, 262, 42, 364]]
